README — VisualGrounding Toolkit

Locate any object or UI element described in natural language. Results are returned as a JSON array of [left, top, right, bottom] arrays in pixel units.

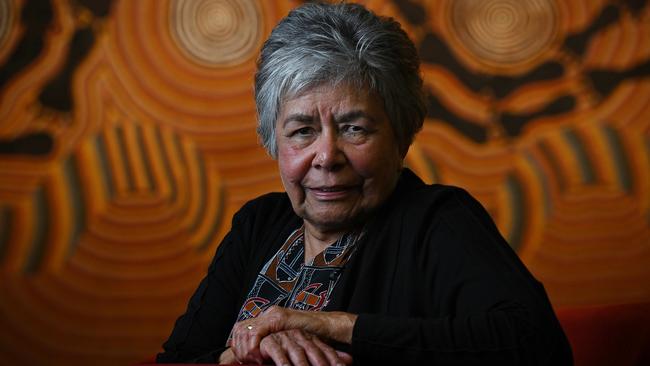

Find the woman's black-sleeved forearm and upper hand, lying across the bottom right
[[232, 296, 571, 365]]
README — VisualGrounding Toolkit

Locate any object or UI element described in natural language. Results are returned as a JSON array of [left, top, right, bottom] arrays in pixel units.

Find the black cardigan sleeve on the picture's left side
[[156, 206, 251, 363]]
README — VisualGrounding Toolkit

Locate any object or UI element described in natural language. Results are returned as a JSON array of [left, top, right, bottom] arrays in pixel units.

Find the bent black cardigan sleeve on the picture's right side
[[350, 190, 572, 365]]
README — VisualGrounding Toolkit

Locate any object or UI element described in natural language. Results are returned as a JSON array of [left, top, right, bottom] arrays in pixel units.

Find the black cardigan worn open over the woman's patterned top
[[157, 169, 573, 365]]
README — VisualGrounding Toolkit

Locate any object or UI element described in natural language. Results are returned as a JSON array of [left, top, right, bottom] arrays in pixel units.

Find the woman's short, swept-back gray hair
[[255, 3, 426, 158]]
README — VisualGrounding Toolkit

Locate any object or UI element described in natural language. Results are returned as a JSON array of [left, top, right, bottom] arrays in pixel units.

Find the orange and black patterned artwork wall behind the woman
[[0, 0, 650, 365]]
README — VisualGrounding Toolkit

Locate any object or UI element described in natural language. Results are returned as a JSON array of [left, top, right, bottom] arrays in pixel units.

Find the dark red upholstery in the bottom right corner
[[556, 303, 650, 366]]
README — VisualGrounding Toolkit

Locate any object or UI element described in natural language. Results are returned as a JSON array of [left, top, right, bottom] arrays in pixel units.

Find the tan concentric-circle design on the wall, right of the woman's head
[[449, 0, 557, 67]]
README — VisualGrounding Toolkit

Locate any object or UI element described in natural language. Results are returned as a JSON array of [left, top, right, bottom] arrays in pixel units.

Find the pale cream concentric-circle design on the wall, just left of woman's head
[[170, 0, 262, 66]]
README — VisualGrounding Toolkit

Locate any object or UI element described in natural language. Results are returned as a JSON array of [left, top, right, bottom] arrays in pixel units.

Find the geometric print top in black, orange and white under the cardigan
[[229, 225, 363, 334]]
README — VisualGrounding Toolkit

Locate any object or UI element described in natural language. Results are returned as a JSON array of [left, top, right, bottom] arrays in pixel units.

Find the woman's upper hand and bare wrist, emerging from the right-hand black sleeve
[[230, 306, 356, 364]]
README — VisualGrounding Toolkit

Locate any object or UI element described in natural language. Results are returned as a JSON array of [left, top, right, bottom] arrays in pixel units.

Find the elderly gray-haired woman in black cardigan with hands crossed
[[158, 4, 571, 365]]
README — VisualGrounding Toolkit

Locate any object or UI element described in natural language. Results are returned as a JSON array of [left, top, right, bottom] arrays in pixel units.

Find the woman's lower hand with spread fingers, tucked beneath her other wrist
[[260, 329, 352, 366]]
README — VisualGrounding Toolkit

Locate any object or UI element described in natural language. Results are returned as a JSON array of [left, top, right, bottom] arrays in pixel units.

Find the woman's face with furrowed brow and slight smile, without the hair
[[275, 85, 403, 233]]
